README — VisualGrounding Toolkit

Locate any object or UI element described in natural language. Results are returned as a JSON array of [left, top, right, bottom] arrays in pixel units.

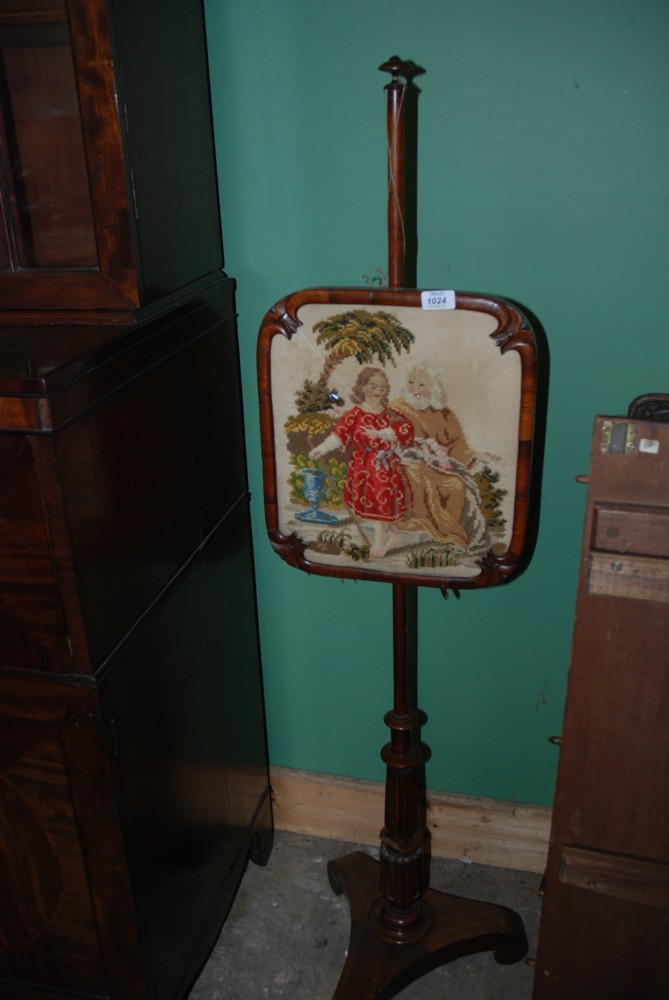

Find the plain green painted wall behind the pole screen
[[202, 0, 669, 803]]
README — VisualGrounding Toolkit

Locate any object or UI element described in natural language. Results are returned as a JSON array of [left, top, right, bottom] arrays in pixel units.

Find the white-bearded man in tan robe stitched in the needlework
[[392, 365, 488, 552]]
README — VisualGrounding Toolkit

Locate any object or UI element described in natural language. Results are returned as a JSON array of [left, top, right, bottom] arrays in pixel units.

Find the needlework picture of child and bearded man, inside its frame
[[271, 303, 521, 578]]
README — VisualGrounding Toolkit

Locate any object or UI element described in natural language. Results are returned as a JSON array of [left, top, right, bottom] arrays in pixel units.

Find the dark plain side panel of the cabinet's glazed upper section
[[111, 0, 223, 302]]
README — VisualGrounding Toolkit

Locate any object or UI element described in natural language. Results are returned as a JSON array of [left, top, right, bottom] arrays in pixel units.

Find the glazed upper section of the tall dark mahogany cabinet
[[0, 0, 223, 318]]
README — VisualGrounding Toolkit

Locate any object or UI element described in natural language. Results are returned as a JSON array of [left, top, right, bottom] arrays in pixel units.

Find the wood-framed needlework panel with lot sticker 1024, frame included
[[258, 288, 536, 589]]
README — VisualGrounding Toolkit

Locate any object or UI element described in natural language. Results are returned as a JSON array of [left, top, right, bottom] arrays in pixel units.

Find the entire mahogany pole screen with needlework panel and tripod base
[[258, 57, 536, 1000]]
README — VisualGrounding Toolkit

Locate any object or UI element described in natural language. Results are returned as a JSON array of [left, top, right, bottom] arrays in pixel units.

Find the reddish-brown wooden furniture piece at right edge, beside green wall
[[533, 416, 669, 1000]]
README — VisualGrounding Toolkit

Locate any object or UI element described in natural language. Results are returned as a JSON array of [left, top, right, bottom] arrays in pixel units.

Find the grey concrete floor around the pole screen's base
[[190, 831, 540, 1000]]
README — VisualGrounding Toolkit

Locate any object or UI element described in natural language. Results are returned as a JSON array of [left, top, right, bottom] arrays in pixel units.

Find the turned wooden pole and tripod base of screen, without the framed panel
[[328, 62, 527, 1000]]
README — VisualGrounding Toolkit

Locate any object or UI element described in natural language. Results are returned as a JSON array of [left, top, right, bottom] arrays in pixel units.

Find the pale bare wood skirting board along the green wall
[[270, 767, 551, 872]]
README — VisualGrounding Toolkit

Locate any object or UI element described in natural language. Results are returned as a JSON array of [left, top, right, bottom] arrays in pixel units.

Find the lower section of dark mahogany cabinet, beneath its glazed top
[[0, 284, 271, 1000]]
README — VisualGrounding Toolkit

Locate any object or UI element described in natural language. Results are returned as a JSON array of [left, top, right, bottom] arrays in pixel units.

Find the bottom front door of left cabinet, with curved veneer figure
[[0, 675, 138, 996]]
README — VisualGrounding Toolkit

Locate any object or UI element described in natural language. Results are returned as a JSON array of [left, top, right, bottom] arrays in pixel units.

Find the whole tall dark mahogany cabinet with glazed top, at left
[[0, 0, 272, 1000]]
